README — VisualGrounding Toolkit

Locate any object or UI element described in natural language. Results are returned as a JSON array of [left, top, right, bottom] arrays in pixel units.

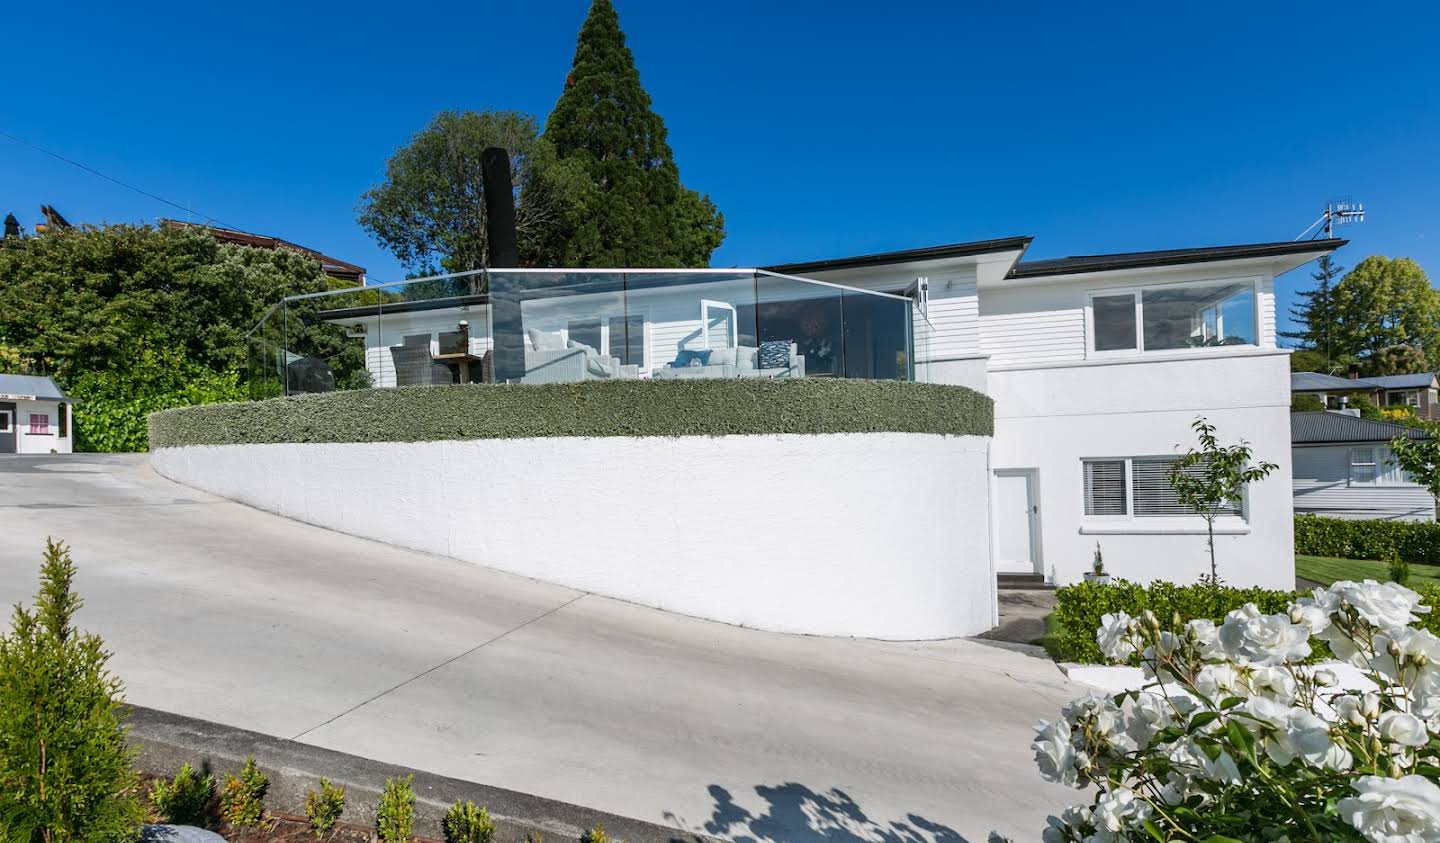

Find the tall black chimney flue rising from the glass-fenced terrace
[[480, 147, 526, 383]]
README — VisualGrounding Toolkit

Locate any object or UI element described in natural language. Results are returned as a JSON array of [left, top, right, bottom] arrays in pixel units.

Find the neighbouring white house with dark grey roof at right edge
[[1290, 411, 1436, 522]]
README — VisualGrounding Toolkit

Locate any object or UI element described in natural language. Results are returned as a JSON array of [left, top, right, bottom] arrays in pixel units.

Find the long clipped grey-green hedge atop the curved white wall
[[150, 379, 995, 448]]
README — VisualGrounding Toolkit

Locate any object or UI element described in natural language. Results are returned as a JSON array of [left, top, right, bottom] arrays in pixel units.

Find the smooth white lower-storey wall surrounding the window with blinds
[[989, 350, 1295, 588]]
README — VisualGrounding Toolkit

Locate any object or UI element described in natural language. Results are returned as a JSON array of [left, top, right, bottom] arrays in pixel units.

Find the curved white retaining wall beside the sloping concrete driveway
[[151, 434, 996, 638]]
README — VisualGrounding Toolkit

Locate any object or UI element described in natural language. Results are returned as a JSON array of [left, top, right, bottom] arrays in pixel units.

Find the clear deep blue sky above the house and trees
[[0, 0, 1440, 334]]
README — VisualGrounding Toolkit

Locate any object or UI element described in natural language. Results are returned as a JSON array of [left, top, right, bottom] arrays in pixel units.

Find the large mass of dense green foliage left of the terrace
[[0, 225, 364, 451]]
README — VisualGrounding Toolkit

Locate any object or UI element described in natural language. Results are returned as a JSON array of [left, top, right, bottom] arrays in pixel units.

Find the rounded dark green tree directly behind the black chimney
[[359, 111, 590, 275]]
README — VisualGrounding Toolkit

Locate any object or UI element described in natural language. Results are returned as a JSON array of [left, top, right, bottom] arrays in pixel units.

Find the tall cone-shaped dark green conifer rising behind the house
[[544, 0, 724, 267]]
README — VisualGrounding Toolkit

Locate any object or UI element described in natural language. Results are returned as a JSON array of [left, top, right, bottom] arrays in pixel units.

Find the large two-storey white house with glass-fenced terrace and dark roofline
[[256, 238, 1344, 588]]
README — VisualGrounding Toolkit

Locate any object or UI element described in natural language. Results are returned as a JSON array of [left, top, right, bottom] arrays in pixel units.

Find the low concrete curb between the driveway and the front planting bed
[[128, 706, 714, 843]]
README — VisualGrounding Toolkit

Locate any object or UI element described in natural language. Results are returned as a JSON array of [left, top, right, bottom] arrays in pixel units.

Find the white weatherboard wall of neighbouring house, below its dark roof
[[1295, 442, 1436, 522]]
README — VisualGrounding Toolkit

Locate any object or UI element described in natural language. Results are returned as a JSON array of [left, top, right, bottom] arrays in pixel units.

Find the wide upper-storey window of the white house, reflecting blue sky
[[1090, 281, 1256, 352]]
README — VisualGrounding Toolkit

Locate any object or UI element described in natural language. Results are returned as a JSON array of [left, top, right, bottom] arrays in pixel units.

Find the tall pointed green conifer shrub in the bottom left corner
[[0, 540, 144, 843]]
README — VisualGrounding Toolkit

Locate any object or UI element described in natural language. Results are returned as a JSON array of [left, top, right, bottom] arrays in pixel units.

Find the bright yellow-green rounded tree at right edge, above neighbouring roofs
[[1332, 255, 1440, 367]]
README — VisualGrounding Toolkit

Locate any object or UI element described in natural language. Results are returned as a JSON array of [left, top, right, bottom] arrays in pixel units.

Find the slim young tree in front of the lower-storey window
[[1169, 418, 1279, 586]]
